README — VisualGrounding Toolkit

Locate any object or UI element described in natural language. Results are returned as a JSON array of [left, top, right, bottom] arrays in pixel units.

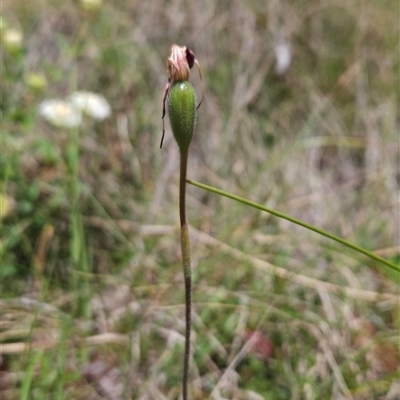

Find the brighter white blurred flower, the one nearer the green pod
[[68, 91, 111, 121]]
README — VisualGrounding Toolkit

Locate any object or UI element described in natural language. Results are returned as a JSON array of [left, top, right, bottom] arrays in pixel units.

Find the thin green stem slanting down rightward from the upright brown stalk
[[187, 180, 400, 272]]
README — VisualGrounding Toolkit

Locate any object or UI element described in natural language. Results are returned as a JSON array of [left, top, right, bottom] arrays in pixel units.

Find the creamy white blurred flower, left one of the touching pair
[[38, 99, 82, 128]]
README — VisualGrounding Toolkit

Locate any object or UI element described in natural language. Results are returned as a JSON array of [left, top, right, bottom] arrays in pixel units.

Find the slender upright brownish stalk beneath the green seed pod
[[179, 151, 192, 400]]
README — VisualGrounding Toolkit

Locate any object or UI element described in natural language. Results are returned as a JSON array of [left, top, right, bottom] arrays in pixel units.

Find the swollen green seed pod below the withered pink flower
[[168, 81, 196, 152]]
